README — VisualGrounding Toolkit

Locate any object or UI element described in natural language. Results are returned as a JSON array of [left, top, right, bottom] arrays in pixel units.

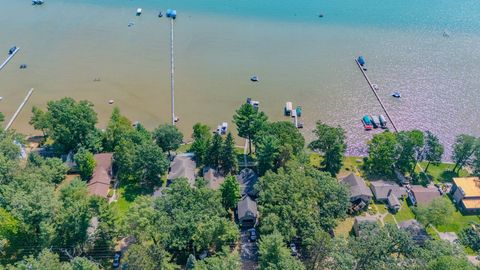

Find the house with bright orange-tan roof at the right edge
[[452, 177, 480, 214]]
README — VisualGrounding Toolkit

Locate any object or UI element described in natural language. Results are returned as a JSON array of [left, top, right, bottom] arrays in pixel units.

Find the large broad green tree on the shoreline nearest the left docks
[[31, 98, 97, 153]]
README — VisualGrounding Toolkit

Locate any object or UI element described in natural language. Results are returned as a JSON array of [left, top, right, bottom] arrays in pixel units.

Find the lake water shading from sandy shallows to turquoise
[[0, 0, 480, 154]]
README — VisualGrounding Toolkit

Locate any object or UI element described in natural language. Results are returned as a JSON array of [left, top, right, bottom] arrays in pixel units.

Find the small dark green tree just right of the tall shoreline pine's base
[[256, 135, 280, 175]]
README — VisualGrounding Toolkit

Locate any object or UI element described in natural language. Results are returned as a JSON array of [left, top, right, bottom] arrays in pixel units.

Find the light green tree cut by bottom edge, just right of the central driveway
[[258, 233, 305, 270]]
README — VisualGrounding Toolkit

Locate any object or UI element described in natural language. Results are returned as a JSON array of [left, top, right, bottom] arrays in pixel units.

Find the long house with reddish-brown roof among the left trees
[[87, 153, 113, 198]]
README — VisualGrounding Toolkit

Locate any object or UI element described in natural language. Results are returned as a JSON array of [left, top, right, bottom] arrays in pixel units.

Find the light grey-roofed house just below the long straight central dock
[[167, 154, 197, 187]]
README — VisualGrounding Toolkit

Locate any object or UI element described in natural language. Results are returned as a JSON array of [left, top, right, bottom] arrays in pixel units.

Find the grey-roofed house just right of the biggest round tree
[[340, 173, 373, 211]]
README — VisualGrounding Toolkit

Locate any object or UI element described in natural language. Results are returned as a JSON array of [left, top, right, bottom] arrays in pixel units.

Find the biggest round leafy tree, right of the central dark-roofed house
[[255, 162, 350, 241]]
